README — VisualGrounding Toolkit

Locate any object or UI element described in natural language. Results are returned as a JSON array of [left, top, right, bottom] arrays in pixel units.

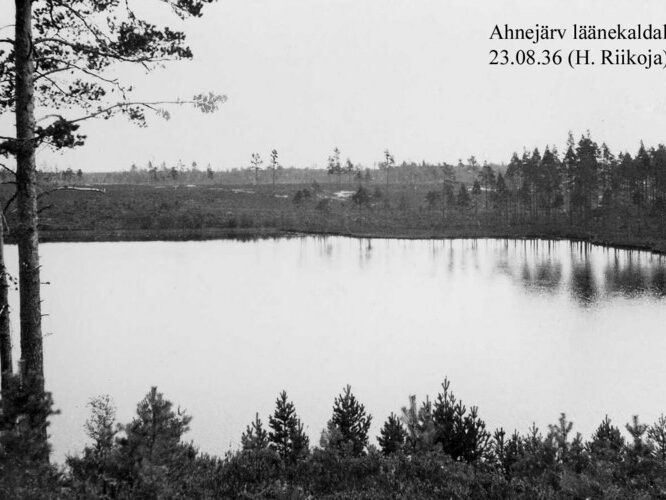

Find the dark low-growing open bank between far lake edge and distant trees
[[2, 184, 666, 253]]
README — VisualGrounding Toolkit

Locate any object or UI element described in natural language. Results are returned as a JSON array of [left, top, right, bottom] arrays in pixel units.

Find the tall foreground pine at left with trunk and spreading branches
[[0, 0, 226, 460]]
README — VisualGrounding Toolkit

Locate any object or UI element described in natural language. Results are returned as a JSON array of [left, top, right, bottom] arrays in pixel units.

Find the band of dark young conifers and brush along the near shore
[[0, 380, 666, 499]]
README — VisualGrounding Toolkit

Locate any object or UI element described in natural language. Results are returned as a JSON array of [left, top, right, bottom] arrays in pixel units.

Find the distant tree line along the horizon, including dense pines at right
[[40, 132, 666, 225]]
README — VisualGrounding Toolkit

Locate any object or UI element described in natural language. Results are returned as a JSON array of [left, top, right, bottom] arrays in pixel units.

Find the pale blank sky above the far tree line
[[0, 0, 666, 171]]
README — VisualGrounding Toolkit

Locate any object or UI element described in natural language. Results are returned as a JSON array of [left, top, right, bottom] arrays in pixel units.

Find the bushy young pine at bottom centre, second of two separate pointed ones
[[328, 385, 372, 456]]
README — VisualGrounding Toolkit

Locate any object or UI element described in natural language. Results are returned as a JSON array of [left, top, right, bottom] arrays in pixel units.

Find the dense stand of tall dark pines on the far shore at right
[[464, 133, 666, 229]]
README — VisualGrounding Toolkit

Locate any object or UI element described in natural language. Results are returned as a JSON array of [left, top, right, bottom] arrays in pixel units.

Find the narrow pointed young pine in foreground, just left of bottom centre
[[268, 391, 309, 462]]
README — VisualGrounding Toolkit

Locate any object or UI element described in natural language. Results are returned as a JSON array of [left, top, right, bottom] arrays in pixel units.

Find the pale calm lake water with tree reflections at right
[[8, 237, 666, 460]]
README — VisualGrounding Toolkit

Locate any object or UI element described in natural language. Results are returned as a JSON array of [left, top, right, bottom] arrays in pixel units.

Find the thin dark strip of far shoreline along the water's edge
[[10, 227, 666, 255]]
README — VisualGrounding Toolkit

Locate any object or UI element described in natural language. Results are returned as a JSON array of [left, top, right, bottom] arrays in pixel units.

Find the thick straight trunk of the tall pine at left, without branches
[[15, 0, 44, 392]]
